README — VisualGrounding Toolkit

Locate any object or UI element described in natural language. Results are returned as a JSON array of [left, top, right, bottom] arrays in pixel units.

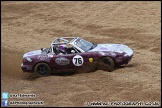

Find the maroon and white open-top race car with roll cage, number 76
[[21, 37, 133, 76]]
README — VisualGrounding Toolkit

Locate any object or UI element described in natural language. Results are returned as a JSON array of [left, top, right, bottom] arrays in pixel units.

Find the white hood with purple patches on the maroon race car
[[89, 44, 133, 56]]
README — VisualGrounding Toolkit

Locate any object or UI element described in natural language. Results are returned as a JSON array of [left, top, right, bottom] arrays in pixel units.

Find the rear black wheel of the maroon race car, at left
[[34, 63, 51, 76]]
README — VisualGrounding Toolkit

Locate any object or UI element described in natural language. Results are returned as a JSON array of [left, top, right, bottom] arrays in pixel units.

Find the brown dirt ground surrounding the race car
[[1, 1, 161, 107]]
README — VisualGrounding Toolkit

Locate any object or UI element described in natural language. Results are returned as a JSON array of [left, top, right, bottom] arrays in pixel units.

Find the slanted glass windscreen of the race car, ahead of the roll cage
[[75, 39, 93, 51]]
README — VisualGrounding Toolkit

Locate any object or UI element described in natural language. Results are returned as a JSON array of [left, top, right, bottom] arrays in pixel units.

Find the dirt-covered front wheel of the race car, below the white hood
[[98, 57, 115, 72]]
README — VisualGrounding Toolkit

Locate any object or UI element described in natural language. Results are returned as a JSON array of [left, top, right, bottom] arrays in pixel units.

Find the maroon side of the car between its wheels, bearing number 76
[[50, 52, 95, 71]]
